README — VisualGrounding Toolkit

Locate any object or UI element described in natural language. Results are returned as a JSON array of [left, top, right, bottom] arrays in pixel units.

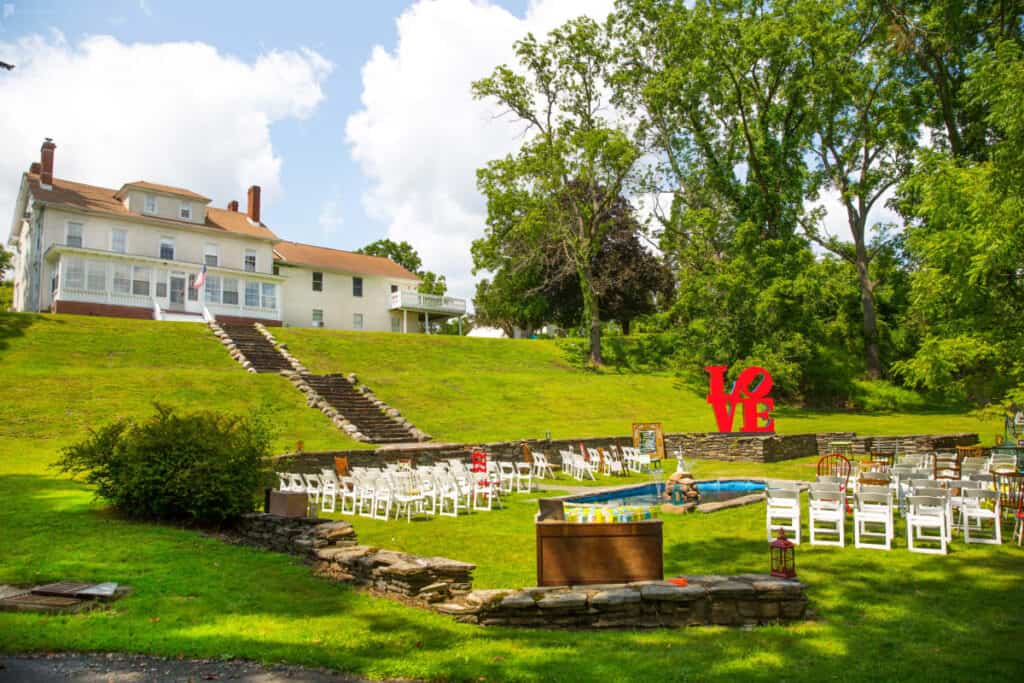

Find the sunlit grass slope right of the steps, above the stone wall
[[274, 329, 1001, 442]]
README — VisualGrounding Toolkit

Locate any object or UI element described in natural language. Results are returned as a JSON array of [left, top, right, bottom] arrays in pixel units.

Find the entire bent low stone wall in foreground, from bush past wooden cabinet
[[233, 513, 807, 629]]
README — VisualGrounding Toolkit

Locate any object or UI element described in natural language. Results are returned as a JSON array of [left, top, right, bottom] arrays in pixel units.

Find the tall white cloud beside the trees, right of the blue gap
[[346, 0, 612, 297]]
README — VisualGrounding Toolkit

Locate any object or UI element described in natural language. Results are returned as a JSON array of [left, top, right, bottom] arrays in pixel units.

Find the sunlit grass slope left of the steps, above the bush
[[0, 313, 359, 462]]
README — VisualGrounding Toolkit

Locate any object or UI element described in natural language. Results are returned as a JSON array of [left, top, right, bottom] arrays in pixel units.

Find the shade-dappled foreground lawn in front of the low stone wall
[[0, 475, 1024, 681]]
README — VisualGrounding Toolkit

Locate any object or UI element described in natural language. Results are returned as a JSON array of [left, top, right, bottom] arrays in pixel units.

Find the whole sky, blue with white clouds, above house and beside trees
[[0, 0, 891, 298]]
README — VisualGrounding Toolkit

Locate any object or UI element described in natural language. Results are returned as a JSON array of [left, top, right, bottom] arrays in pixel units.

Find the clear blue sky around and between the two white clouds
[[0, 0, 552, 296]]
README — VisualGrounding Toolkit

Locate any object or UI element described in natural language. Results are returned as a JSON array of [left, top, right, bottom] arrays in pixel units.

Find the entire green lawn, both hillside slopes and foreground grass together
[[0, 314, 1024, 681]]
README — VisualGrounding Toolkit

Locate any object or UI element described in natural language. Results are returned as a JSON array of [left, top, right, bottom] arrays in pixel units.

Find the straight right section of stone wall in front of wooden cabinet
[[437, 574, 807, 629]]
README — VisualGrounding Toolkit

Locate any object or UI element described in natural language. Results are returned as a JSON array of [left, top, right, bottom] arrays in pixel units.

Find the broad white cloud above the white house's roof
[[0, 32, 331, 220]]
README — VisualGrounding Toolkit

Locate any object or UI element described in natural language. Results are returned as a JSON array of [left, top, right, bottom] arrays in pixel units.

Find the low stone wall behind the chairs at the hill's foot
[[273, 432, 978, 472]]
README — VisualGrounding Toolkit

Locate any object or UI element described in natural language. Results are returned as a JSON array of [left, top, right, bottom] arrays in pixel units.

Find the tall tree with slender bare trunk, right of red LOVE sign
[[803, 0, 921, 379]]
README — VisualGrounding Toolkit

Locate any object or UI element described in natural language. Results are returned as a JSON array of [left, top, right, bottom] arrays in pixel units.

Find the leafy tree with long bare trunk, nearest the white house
[[473, 17, 640, 366]]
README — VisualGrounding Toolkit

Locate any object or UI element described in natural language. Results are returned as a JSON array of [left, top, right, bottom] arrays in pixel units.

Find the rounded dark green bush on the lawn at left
[[56, 404, 270, 523]]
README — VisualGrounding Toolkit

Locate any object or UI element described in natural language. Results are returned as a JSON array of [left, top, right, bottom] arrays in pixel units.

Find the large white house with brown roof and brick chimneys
[[7, 138, 466, 332]]
